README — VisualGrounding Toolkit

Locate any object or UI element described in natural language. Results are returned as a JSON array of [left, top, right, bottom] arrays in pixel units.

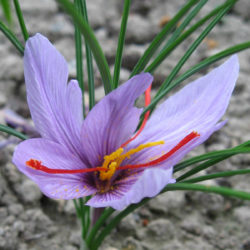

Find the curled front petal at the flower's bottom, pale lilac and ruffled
[[87, 168, 175, 210]]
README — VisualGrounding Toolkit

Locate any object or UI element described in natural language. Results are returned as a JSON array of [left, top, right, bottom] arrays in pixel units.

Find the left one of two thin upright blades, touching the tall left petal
[[74, 0, 85, 116]]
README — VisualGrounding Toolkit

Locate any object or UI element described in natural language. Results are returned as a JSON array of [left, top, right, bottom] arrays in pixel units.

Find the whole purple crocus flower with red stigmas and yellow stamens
[[13, 34, 239, 210]]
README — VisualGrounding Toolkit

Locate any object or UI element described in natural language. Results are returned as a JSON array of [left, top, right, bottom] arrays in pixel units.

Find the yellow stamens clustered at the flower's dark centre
[[99, 141, 164, 181]]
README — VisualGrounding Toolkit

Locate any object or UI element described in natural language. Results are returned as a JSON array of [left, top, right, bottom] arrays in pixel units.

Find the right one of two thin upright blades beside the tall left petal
[[80, 0, 95, 110]]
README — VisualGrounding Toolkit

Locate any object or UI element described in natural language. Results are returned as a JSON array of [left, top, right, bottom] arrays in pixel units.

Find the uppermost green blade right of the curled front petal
[[174, 141, 250, 173]]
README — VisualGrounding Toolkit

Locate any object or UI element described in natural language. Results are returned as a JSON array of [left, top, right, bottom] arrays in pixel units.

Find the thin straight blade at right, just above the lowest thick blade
[[181, 169, 250, 183]]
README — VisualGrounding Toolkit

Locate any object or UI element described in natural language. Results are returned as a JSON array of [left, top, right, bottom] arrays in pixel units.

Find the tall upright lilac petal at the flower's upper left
[[24, 34, 83, 158]]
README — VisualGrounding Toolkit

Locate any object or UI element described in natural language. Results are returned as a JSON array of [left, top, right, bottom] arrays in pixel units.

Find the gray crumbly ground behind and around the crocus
[[0, 0, 250, 250]]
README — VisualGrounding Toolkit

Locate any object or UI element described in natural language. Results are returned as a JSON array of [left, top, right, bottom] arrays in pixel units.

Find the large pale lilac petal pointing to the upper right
[[126, 56, 239, 168]]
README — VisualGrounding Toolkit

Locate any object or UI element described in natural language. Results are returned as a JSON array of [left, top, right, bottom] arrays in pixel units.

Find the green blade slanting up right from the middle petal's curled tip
[[145, 0, 228, 73]]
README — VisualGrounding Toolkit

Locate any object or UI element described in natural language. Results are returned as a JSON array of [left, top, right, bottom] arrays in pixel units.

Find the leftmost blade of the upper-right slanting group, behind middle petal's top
[[130, 0, 199, 77]]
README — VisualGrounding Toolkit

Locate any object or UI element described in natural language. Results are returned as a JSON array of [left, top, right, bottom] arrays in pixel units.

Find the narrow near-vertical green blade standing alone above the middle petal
[[113, 0, 131, 88]]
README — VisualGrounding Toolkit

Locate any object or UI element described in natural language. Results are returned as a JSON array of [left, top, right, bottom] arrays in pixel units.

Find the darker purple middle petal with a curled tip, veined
[[81, 73, 153, 166]]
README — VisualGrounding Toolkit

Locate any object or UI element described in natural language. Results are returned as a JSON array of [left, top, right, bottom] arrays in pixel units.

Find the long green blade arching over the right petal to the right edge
[[141, 42, 250, 119]]
